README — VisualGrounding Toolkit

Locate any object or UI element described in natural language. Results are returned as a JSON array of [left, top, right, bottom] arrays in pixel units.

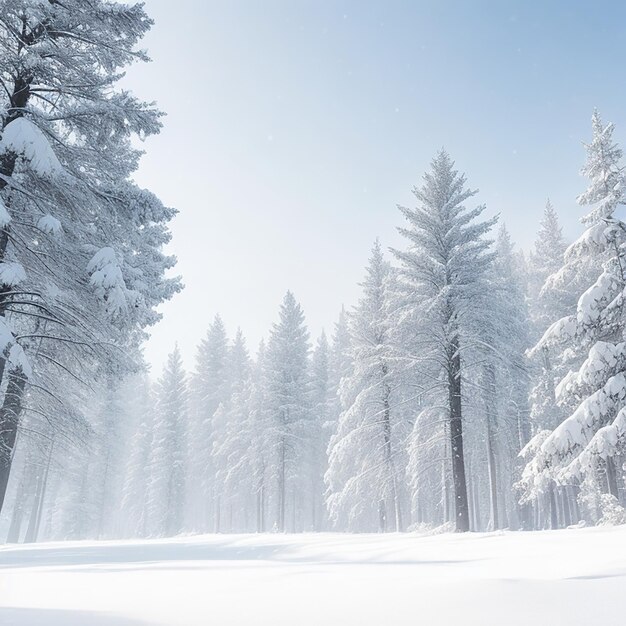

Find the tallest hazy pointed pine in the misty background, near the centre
[[266, 291, 311, 532]]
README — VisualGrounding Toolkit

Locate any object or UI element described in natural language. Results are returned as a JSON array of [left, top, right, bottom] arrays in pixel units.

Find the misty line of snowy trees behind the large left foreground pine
[[8, 108, 626, 540]]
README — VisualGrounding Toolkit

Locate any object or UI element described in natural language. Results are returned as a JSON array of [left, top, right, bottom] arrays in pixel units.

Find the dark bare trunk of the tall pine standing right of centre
[[448, 339, 469, 532]]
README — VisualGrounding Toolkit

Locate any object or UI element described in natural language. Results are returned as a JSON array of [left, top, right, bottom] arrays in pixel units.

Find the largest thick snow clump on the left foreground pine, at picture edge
[[0, 117, 63, 178]]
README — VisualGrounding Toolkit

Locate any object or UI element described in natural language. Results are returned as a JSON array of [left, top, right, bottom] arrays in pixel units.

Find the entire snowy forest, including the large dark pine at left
[[0, 0, 626, 543]]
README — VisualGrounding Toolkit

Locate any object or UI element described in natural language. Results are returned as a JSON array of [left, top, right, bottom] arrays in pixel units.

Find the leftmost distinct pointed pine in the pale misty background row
[[147, 346, 188, 537]]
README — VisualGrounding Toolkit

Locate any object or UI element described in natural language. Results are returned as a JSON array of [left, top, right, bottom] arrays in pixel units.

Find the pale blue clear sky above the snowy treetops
[[127, 0, 626, 372]]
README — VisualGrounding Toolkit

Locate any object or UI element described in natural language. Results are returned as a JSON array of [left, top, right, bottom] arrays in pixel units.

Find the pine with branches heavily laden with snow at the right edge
[[523, 111, 626, 519]]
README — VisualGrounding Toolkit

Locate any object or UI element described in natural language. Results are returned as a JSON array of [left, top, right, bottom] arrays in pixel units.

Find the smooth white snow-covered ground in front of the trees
[[0, 527, 626, 626]]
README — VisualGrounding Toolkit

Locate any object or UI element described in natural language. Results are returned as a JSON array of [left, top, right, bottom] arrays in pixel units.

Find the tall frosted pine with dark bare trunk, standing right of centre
[[394, 150, 495, 531]]
